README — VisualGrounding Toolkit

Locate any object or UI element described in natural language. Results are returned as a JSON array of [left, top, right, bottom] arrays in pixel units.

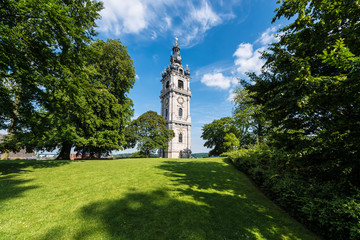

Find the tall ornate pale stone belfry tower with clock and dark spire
[[160, 38, 191, 158]]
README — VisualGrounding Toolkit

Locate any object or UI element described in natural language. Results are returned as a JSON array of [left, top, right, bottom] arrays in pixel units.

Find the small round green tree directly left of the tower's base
[[127, 111, 175, 157]]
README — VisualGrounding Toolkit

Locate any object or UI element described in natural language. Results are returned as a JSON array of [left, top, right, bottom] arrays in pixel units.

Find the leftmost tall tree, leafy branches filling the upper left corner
[[0, 0, 102, 158]]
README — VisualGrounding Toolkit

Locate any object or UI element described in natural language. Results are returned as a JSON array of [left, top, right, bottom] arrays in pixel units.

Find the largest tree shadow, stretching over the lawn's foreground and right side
[[70, 158, 316, 240]]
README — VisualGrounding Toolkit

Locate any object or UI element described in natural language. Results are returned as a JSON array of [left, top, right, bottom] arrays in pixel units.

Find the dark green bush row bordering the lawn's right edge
[[224, 144, 360, 240]]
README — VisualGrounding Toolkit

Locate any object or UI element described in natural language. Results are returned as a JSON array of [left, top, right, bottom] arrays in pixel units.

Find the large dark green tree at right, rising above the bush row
[[247, 0, 360, 185]]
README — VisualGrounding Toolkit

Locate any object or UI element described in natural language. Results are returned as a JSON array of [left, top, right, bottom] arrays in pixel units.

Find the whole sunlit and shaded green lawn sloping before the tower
[[0, 158, 318, 240]]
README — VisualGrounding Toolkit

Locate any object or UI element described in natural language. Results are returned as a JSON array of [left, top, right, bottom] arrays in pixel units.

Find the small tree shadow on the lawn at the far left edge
[[0, 160, 69, 201]]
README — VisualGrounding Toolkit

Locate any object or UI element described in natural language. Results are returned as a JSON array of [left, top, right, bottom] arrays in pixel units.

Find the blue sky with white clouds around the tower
[[97, 0, 281, 153]]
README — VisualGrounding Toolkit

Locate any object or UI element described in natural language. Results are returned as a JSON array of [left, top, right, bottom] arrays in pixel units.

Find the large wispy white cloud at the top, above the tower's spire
[[98, 0, 241, 47]]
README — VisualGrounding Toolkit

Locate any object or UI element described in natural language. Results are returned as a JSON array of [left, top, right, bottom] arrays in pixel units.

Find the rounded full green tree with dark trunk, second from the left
[[32, 40, 135, 159]]
